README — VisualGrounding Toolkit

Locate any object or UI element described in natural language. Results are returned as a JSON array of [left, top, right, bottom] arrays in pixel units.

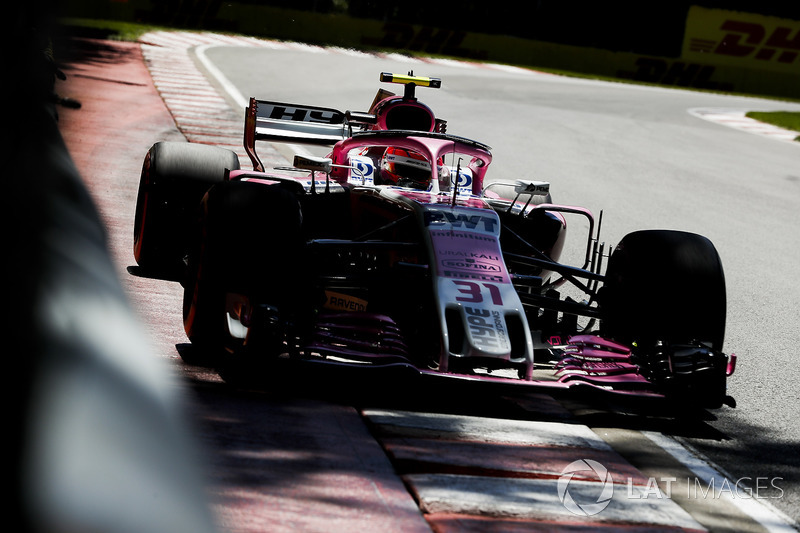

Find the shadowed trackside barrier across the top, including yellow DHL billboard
[[62, 0, 800, 98]]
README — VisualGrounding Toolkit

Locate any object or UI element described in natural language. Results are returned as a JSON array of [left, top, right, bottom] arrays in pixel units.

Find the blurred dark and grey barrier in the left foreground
[[6, 2, 215, 533]]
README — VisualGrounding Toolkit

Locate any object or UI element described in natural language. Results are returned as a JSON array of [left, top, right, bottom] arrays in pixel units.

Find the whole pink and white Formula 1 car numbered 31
[[134, 73, 735, 407]]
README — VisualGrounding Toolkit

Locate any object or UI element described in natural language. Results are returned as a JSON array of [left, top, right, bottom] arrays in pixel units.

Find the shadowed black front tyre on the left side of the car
[[183, 181, 303, 367]]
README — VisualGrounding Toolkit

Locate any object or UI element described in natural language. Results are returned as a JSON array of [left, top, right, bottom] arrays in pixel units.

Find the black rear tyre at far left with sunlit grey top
[[133, 142, 239, 277]]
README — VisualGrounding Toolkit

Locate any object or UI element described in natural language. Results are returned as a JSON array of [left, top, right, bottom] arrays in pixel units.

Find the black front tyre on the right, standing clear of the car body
[[600, 230, 727, 407]]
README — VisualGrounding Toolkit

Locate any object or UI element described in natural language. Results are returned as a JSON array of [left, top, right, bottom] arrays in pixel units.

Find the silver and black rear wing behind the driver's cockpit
[[244, 98, 375, 172]]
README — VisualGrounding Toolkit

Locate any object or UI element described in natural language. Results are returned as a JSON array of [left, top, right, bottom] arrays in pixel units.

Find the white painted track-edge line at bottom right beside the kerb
[[642, 431, 799, 533]]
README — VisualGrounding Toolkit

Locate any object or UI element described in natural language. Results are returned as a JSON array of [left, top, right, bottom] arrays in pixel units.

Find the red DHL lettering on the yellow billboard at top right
[[689, 20, 800, 63]]
